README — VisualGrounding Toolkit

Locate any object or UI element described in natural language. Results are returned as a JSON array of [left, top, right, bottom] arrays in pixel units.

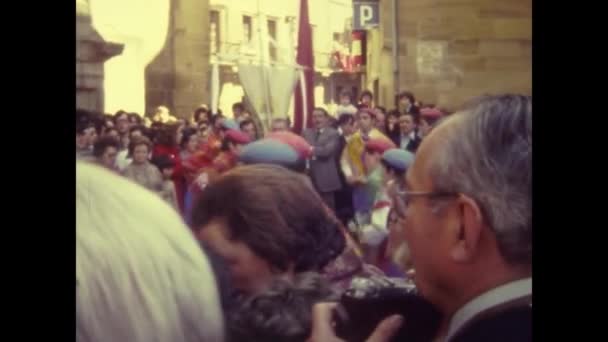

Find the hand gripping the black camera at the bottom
[[307, 303, 403, 342]]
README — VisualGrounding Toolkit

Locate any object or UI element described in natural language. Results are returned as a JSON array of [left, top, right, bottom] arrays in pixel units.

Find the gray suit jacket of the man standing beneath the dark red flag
[[302, 127, 342, 192]]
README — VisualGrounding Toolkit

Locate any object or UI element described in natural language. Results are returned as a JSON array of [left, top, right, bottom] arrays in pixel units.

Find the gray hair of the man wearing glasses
[[429, 95, 532, 264]]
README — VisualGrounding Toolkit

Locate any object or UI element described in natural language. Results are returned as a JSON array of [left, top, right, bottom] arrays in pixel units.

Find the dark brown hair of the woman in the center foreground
[[192, 164, 345, 272]]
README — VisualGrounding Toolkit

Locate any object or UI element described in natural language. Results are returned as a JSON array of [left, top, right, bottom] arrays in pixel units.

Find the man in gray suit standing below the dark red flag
[[302, 108, 342, 210]]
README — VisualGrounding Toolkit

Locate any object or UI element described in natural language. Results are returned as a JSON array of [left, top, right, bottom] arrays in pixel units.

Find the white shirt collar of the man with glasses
[[445, 277, 532, 342]]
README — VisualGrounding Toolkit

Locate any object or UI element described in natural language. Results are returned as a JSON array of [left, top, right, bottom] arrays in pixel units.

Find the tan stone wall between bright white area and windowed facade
[[146, 0, 210, 118]]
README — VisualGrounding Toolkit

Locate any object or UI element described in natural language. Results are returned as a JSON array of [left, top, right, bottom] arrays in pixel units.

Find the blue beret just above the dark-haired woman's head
[[239, 139, 299, 168]]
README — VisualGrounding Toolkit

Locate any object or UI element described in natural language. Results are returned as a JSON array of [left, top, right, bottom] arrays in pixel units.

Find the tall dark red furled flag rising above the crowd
[[293, 0, 315, 134]]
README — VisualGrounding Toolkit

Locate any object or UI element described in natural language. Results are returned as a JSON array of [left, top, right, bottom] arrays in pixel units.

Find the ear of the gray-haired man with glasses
[[451, 195, 483, 263]]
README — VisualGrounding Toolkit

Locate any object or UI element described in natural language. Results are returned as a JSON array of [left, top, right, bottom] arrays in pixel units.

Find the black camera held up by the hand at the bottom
[[334, 277, 442, 342]]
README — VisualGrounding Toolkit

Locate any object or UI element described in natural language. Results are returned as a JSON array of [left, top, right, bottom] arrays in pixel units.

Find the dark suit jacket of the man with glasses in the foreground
[[449, 305, 532, 342]]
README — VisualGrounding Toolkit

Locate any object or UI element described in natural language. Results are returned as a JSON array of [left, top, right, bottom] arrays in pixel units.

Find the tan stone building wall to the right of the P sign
[[365, 0, 532, 109]]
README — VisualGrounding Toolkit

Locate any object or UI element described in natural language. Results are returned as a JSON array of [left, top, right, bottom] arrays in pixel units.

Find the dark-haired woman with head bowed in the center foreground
[[192, 164, 381, 293]]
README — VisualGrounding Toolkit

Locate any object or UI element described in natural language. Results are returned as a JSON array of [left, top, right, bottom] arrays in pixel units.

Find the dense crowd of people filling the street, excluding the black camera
[[76, 91, 532, 341]]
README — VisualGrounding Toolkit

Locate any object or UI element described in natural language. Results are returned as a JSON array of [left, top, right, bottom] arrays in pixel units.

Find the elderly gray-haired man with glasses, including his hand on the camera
[[310, 95, 532, 342]]
